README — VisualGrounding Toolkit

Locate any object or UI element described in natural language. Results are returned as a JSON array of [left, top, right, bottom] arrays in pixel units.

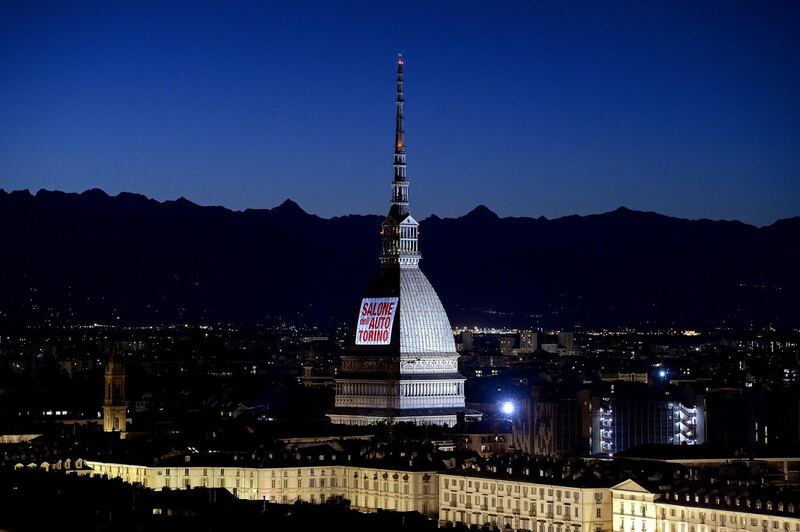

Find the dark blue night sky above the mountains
[[0, 0, 800, 224]]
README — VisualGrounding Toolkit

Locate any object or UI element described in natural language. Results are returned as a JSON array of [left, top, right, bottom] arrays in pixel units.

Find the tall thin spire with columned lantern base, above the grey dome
[[381, 53, 420, 266]]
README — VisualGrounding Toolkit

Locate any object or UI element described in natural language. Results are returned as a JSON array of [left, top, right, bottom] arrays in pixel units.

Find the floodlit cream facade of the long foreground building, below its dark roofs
[[36, 459, 800, 532]]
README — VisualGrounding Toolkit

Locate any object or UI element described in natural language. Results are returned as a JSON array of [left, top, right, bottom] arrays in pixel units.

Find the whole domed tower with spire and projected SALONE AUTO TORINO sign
[[329, 56, 473, 425]]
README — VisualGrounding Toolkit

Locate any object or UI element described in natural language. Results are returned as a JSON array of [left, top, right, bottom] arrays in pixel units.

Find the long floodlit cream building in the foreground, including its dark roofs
[[25, 454, 800, 532]]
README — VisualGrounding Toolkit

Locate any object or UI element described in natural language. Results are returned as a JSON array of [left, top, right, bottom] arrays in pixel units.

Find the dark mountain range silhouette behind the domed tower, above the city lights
[[0, 189, 800, 328]]
